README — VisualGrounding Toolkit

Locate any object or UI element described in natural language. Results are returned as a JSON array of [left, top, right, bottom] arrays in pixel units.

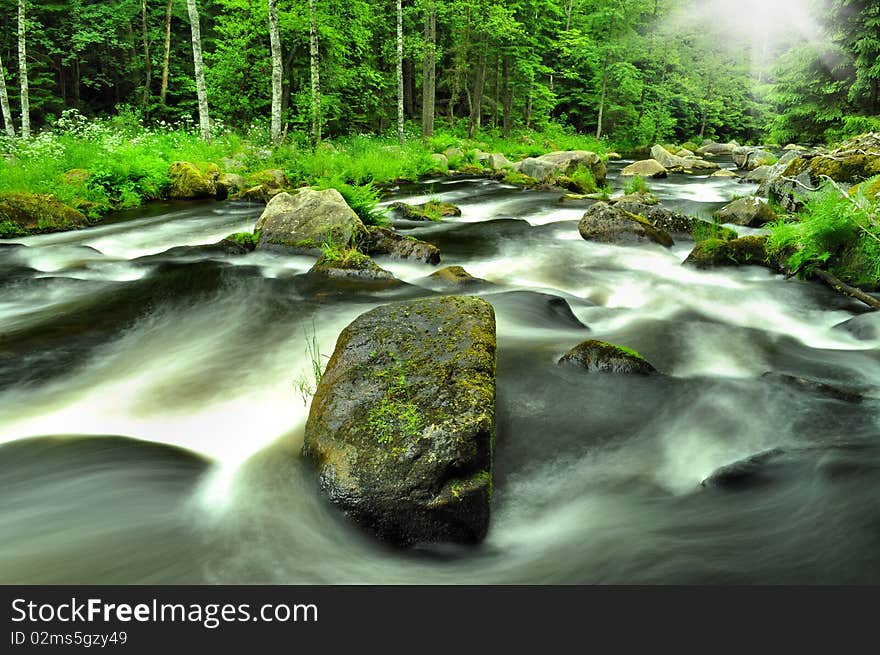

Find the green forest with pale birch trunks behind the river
[[0, 0, 880, 149]]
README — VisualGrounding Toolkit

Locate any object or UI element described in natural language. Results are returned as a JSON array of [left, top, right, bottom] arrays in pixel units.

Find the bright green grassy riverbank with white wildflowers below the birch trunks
[[0, 112, 610, 237]]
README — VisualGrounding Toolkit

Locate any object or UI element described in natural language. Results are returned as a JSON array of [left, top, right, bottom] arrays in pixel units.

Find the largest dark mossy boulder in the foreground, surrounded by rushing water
[[303, 296, 496, 545]]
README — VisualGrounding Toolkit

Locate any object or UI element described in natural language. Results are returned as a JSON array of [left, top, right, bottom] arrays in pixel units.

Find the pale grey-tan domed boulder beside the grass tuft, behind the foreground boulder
[[255, 189, 364, 252]]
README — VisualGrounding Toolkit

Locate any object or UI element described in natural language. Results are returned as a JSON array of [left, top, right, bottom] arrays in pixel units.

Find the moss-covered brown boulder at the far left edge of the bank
[[0, 193, 89, 238]]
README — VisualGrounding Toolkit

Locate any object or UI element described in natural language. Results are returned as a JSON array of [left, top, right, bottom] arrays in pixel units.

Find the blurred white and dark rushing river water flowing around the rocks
[[0, 160, 880, 583]]
